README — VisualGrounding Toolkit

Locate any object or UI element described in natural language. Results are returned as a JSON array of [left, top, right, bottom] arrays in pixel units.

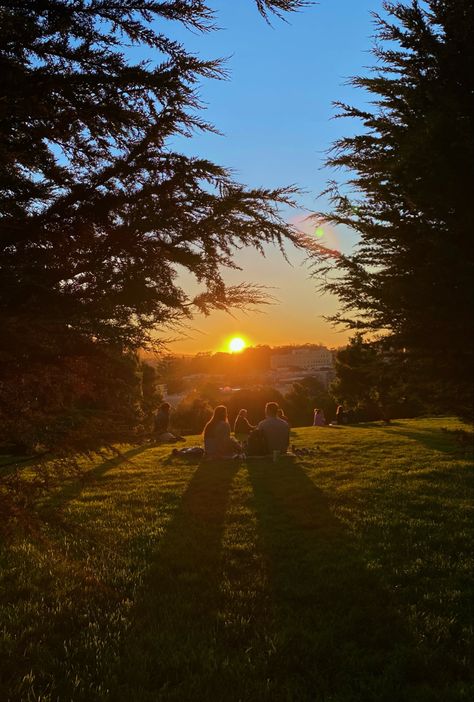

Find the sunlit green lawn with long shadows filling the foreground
[[0, 418, 474, 702]]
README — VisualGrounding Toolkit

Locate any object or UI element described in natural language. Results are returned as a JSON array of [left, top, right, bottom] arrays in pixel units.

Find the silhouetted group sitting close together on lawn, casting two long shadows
[[204, 402, 290, 458]]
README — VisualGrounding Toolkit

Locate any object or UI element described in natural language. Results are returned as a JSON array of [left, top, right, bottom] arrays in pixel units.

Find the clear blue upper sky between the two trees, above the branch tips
[[167, 0, 381, 208]]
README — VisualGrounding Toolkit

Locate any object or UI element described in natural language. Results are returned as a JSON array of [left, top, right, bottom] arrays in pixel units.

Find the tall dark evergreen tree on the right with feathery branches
[[315, 0, 474, 416]]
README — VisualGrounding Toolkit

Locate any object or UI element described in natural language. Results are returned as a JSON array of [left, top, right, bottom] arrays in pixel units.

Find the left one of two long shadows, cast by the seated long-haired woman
[[110, 462, 240, 702]]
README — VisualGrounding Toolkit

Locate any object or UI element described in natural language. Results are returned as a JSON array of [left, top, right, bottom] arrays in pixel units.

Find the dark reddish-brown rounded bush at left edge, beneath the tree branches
[[0, 328, 160, 455]]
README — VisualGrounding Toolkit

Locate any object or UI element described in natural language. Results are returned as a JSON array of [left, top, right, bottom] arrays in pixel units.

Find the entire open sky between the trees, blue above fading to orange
[[157, 0, 382, 353]]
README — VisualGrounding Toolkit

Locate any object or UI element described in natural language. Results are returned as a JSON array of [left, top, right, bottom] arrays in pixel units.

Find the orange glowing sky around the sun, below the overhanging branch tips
[[160, 227, 353, 354]]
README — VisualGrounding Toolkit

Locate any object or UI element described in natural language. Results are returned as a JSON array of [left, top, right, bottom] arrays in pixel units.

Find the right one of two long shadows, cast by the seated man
[[249, 464, 416, 702]]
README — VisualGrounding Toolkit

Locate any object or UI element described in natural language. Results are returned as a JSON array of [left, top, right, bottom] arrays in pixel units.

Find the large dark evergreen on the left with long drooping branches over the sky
[[0, 0, 305, 454]]
